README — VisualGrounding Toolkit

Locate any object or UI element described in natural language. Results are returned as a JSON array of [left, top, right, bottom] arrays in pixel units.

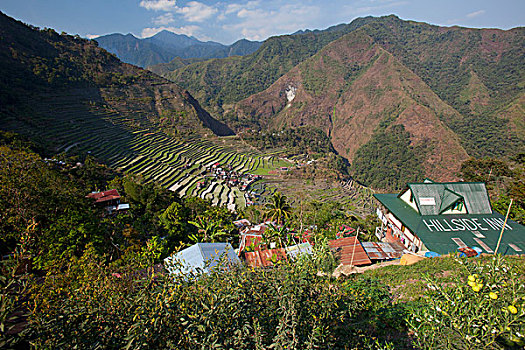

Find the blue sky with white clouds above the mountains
[[0, 0, 525, 44]]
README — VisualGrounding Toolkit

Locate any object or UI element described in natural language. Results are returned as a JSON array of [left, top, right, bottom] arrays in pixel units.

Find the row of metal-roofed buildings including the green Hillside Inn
[[165, 180, 525, 273]]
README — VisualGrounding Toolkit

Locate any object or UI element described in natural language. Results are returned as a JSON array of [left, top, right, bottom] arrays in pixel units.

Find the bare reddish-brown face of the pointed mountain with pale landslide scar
[[236, 28, 468, 180]]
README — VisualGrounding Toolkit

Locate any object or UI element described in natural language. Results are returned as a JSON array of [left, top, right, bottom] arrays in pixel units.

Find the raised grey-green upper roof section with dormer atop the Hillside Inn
[[408, 182, 492, 215]]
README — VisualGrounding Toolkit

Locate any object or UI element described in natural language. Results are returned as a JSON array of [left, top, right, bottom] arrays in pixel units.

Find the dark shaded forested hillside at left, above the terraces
[[0, 10, 232, 146]]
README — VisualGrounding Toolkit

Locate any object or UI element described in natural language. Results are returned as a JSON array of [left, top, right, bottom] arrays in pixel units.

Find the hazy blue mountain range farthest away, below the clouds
[[95, 30, 261, 67]]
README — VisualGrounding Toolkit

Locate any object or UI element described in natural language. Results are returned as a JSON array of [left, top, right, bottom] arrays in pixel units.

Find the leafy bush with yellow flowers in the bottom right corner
[[409, 256, 525, 349]]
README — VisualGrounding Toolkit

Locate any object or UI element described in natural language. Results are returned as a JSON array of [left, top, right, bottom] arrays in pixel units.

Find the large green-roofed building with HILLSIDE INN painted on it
[[374, 180, 525, 255]]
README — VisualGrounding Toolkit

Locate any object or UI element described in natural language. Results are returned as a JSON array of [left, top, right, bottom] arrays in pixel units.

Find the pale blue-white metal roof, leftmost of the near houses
[[164, 243, 241, 274]]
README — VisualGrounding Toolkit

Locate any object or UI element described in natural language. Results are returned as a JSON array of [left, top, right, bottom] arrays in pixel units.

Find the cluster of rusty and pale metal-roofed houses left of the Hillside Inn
[[164, 219, 406, 274]]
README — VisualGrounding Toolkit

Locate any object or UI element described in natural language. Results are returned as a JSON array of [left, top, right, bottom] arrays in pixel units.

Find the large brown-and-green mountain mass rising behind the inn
[[154, 15, 525, 188]]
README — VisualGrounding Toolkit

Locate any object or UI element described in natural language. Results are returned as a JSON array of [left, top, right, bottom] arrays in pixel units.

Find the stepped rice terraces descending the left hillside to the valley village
[[4, 92, 289, 210]]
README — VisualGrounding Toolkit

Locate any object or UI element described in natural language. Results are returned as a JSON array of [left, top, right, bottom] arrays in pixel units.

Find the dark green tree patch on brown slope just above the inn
[[352, 125, 426, 190]]
